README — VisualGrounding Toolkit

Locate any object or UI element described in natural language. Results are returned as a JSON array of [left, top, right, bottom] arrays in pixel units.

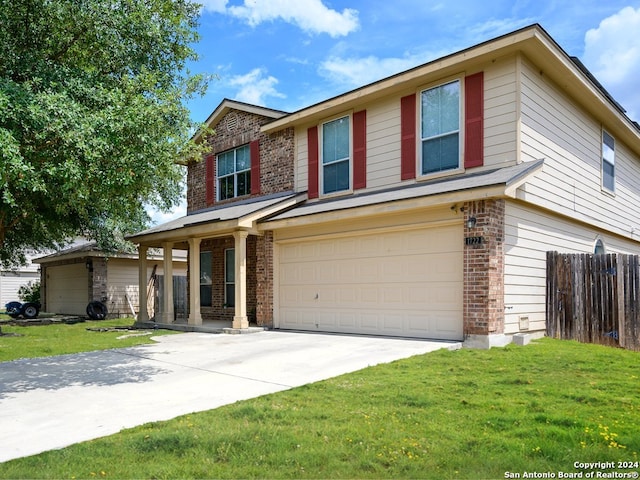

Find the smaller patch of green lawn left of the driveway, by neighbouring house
[[0, 317, 176, 362]]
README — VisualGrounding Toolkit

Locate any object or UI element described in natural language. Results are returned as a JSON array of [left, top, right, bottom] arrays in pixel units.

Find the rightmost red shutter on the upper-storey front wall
[[464, 72, 484, 168]]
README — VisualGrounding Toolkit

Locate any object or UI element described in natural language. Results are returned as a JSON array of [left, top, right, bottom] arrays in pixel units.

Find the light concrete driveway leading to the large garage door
[[0, 331, 460, 462]]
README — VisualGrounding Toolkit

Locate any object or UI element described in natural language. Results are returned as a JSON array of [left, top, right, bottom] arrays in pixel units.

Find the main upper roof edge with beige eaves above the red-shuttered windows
[[262, 24, 640, 154]]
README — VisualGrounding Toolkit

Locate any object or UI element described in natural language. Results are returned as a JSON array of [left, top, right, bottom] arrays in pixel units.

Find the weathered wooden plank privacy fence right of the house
[[547, 252, 640, 350]]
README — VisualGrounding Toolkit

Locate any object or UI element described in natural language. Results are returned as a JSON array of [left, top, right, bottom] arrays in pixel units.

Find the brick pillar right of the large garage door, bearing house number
[[463, 200, 505, 336]]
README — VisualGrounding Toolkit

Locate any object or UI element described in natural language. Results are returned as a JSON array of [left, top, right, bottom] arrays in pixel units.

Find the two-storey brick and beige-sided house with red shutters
[[130, 25, 640, 347]]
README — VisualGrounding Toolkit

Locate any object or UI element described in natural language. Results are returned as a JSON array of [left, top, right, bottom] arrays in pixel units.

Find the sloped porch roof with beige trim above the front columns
[[126, 193, 306, 248]]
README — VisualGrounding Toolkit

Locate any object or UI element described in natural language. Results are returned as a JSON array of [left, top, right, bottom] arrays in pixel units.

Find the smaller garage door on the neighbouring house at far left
[[46, 263, 89, 315]]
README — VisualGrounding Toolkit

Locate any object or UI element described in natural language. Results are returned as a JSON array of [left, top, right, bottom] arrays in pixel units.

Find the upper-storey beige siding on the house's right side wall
[[519, 57, 640, 239]]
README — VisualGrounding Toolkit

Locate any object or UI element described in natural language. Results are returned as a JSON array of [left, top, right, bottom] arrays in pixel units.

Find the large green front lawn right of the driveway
[[0, 339, 640, 479]]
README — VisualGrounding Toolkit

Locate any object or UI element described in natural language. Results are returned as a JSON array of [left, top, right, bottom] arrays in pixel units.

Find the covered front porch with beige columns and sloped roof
[[129, 194, 304, 333]]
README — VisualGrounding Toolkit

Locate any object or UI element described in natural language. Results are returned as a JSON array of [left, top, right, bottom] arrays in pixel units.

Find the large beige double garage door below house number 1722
[[276, 224, 463, 340]]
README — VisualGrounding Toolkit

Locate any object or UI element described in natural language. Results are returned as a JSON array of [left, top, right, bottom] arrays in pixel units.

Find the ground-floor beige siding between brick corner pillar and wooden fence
[[504, 202, 640, 334]]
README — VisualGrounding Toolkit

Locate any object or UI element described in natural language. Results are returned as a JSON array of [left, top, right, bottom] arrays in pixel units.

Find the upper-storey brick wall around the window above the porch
[[187, 110, 294, 213]]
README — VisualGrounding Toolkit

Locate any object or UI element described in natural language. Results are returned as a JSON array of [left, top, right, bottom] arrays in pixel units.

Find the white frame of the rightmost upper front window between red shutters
[[416, 75, 465, 179]]
